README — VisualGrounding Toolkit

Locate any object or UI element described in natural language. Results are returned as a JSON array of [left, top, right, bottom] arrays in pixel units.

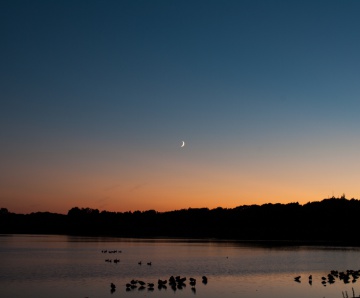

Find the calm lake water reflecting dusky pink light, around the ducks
[[0, 235, 360, 298]]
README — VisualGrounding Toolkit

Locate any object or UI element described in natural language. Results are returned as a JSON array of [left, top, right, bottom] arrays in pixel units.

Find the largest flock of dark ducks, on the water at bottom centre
[[110, 275, 208, 293]]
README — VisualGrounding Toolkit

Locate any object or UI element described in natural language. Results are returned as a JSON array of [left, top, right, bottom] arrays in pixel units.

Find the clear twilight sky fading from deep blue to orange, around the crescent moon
[[0, 0, 360, 213]]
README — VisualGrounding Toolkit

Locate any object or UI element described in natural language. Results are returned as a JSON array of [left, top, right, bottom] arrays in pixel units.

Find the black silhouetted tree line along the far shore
[[0, 195, 360, 246]]
